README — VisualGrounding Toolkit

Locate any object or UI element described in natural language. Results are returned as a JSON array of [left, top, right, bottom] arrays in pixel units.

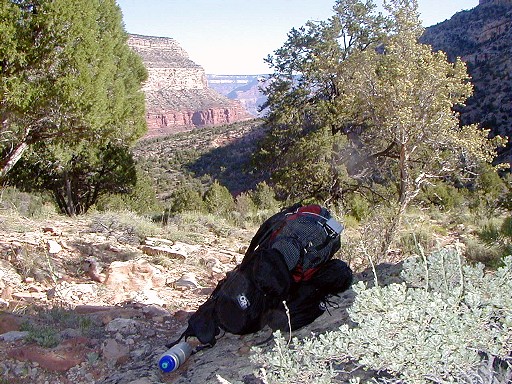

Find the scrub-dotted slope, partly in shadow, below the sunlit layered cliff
[[134, 120, 264, 198]]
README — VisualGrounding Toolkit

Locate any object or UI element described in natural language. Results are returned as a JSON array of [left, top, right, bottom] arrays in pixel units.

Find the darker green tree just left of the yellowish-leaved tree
[[255, 0, 386, 204]]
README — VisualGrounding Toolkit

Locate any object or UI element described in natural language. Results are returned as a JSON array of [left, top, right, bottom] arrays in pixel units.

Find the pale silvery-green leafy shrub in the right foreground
[[254, 249, 512, 384]]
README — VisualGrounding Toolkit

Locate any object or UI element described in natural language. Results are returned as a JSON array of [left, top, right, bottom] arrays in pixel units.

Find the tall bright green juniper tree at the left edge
[[0, 0, 147, 214]]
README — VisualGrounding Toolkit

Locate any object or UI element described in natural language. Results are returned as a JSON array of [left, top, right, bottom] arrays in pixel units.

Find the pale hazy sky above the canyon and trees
[[117, 0, 478, 75]]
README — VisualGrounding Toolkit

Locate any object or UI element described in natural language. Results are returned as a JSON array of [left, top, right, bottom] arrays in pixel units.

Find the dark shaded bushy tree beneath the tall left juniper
[[10, 142, 137, 215]]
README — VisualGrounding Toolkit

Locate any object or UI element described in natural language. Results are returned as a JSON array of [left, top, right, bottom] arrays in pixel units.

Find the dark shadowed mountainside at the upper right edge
[[422, 0, 512, 164]]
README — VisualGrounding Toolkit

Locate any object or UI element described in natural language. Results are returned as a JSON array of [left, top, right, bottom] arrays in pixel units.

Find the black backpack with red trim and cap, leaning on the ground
[[169, 204, 343, 346]]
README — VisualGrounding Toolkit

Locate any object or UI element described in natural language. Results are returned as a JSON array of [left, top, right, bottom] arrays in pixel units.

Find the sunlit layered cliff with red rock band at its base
[[128, 35, 251, 137]]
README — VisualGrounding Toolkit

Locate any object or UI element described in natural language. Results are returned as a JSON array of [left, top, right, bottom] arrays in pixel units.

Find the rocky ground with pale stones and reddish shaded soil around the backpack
[[0, 215, 399, 384]]
